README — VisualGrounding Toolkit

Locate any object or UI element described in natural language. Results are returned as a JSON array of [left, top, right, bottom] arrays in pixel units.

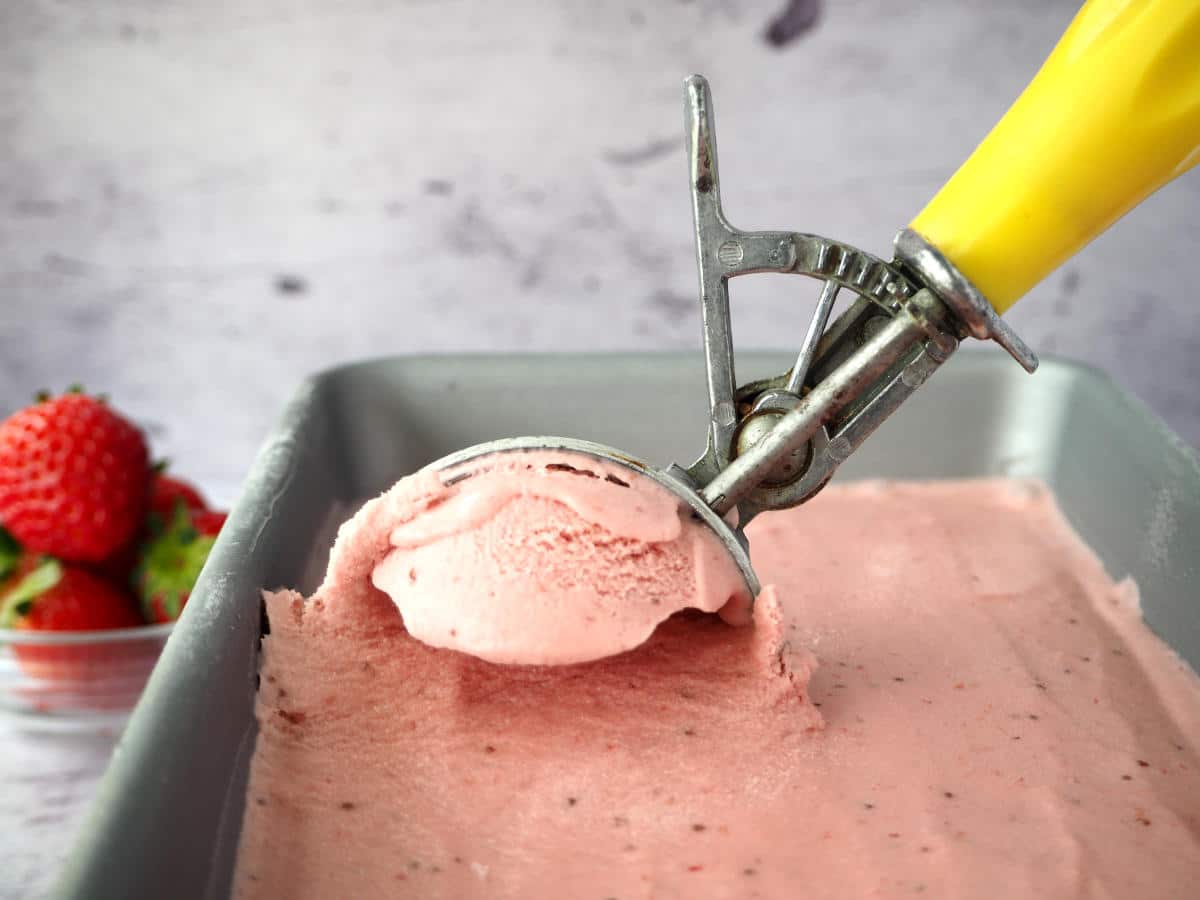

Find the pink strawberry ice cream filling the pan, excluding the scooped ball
[[235, 481, 1200, 900]]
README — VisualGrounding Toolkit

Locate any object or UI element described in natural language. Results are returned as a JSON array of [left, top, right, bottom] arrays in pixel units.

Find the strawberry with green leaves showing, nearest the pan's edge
[[138, 505, 226, 622]]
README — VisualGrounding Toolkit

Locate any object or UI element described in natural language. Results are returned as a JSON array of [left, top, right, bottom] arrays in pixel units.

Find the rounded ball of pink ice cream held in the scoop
[[369, 450, 750, 665]]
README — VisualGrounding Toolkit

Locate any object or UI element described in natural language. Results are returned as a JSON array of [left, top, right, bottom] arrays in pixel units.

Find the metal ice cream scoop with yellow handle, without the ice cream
[[434, 0, 1200, 607]]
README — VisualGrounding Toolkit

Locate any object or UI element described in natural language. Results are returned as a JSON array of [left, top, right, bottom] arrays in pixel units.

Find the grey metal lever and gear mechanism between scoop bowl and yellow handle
[[666, 76, 1037, 532]]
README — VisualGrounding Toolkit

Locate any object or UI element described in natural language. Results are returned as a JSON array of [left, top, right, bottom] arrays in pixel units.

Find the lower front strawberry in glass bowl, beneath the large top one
[[0, 553, 142, 682]]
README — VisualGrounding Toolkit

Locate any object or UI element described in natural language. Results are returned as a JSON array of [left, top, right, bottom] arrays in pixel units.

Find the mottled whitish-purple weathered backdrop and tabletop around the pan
[[0, 0, 1200, 896]]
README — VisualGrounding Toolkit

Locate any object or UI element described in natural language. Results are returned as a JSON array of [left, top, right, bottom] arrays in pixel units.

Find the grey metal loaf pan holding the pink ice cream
[[58, 350, 1200, 900]]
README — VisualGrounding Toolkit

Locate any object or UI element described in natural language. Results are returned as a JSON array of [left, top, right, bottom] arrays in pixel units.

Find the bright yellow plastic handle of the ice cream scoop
[[908, 0, 1200, 312]]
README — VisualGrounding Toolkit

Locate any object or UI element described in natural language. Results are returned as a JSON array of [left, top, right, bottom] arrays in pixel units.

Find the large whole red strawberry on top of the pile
[[0, 392, 150, 563]]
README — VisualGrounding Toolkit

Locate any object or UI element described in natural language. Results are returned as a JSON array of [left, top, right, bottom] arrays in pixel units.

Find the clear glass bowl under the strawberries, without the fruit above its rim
[[0, 623, 174, 731]]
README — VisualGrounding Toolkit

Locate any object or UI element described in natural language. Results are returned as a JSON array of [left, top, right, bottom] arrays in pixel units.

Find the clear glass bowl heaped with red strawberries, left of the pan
[[0, 389, 224, 730]]
